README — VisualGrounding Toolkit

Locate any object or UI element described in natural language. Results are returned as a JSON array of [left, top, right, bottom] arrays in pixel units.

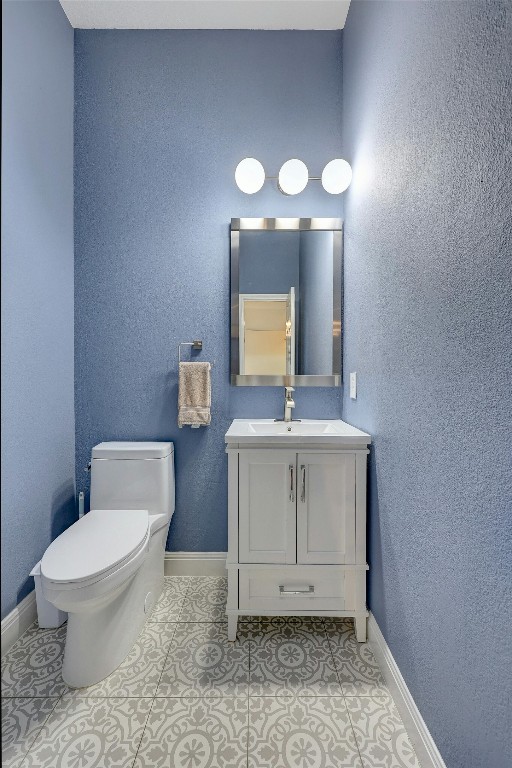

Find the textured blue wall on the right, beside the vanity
[[343, 2, 512, 768]]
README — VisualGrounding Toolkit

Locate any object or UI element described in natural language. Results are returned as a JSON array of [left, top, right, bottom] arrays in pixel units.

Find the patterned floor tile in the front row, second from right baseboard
[[249, 696, 361, 768]]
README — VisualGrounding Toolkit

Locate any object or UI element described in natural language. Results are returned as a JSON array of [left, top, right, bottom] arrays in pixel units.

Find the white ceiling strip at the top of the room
[[60, 0, 350, 29]]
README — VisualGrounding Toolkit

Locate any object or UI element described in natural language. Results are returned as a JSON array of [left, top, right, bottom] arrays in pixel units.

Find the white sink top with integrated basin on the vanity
[[225, 419, 371, 447]]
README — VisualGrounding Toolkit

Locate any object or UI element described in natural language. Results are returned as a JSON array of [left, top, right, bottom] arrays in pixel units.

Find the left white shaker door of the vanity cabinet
[[238, 449, 297, 563]]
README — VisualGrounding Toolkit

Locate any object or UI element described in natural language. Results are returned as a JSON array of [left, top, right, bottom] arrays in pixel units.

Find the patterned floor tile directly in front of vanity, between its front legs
[[247, 618, 342, 696]]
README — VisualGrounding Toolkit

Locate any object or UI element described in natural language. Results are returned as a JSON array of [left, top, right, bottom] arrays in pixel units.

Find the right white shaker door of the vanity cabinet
[[297, 453, 356, 565]]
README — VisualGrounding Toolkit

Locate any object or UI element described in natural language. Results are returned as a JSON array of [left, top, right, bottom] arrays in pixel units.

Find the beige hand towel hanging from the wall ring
[[178, 363, 212, 427]]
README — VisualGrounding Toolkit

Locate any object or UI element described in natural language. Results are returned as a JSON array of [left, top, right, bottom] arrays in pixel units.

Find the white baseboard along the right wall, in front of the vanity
[[368, 613, 446, 768]]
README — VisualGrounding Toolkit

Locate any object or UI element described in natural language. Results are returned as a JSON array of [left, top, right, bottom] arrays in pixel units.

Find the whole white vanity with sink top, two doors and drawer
[[225, 419, 371, 642]]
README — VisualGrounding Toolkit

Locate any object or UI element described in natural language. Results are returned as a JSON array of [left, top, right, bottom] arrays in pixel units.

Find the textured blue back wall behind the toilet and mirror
[[75, 30, 342, 551]]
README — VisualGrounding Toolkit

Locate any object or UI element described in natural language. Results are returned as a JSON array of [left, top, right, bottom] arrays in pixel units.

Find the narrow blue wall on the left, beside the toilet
[[2, 0, 76, 617]]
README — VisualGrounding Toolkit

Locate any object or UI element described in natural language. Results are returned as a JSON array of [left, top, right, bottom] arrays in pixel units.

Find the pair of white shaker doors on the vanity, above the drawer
[[238, 448, 355, 565]]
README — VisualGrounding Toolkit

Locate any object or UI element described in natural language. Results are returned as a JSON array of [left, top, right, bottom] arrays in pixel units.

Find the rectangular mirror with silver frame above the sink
[[231, 218, 342, 387]]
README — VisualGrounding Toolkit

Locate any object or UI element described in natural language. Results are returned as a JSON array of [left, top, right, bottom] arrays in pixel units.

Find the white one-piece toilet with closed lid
[[41, 442, 174, 688]]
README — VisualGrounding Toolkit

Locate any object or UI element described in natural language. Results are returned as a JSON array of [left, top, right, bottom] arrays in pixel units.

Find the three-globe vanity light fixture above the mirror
[[235, 157, 352, 195]]
